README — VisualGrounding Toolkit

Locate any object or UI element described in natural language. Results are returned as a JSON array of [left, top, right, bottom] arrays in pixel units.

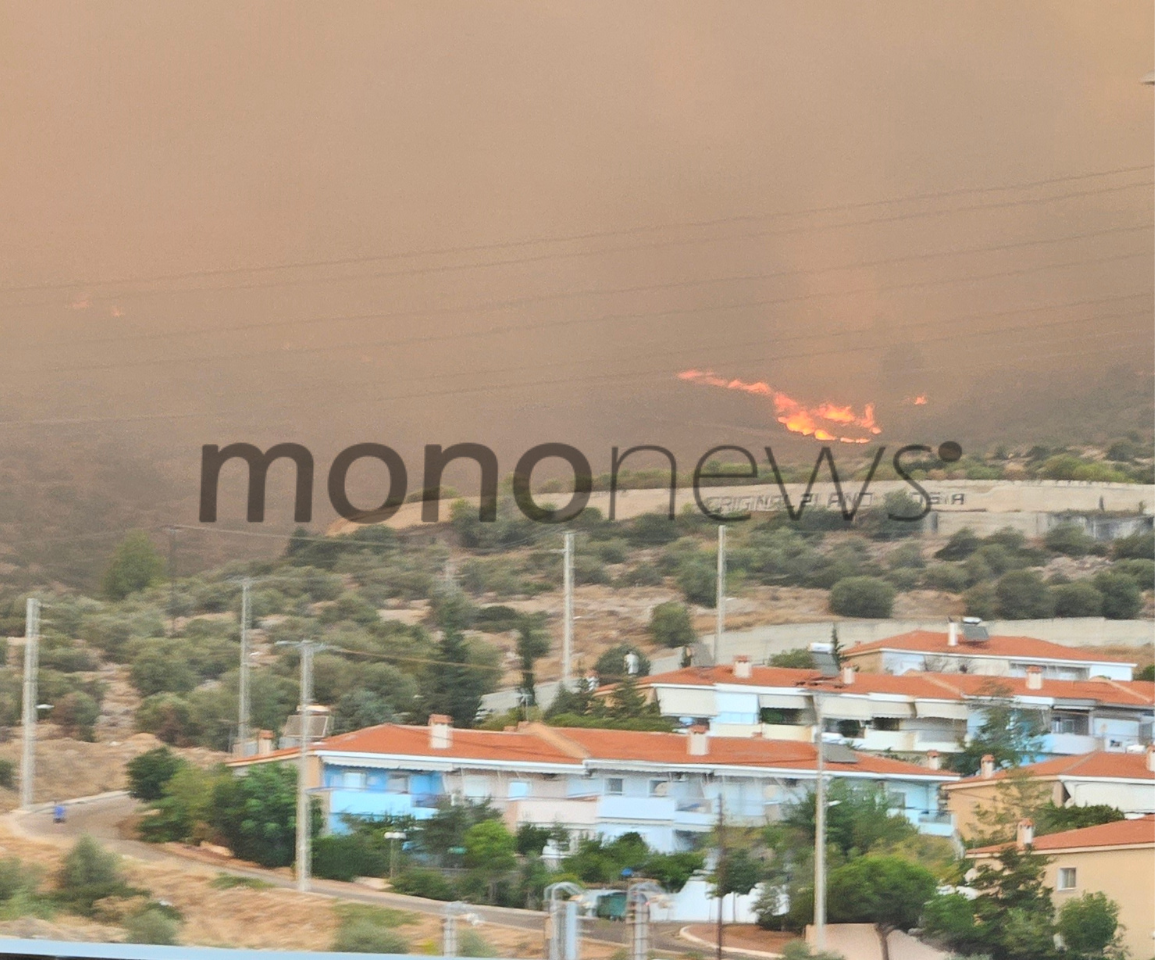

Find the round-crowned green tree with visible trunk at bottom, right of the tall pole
[[827, 855, 936, 960]]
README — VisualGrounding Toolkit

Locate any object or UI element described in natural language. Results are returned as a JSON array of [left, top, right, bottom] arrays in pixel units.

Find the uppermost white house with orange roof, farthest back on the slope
[[842, 622, 1135, 680]]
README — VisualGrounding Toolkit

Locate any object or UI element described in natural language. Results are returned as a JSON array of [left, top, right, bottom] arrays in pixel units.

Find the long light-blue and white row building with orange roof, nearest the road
[[230, 716, 956, 851]]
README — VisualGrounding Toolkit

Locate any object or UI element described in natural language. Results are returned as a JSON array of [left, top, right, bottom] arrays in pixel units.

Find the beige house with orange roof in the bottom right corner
[[967, 817, 1155, 960]]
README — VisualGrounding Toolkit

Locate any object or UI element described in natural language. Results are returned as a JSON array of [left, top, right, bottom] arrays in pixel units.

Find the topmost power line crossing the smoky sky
[[0, 164, 1153, 293]]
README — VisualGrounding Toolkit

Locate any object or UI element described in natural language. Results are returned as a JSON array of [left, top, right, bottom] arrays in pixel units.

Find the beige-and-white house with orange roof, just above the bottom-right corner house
[[944, 746, 1155, 838]]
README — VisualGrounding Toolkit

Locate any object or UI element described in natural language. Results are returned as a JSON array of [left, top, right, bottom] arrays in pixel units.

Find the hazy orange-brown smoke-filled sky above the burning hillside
[[0, 0, 1155, 526]]
